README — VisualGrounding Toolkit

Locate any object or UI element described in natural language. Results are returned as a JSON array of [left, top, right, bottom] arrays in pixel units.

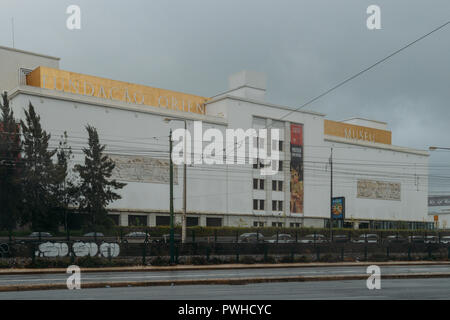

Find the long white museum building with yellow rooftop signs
[[0, 47, 433, 229]]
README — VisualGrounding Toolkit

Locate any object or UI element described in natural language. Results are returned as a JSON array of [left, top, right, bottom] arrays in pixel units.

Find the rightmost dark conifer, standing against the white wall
[[75, 125, 126, 231]]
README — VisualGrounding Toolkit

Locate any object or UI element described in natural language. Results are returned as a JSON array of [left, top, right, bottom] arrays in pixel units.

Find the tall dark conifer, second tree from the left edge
[[21, 102, 58, 231]]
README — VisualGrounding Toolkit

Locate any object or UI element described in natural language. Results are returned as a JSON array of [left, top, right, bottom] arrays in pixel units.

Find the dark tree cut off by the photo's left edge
[[0, 92, 22, 235]]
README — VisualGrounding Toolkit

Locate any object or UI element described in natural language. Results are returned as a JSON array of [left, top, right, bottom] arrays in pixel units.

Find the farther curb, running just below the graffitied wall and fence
[[0, 261, 450, 276]]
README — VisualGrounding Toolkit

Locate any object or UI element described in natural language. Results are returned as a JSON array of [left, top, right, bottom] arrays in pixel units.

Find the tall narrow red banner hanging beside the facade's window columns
[[291, 123, 303, 213]]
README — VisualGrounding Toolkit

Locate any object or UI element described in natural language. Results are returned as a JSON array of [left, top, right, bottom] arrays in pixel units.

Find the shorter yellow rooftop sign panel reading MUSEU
[[324, 120, 392, 144]]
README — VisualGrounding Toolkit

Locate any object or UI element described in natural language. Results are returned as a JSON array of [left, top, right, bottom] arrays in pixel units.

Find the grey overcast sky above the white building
[[0, 0, 450, 191]]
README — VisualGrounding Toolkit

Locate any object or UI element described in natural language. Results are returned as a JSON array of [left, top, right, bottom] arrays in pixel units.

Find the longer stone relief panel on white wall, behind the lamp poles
[[109, 155, 178, 184]]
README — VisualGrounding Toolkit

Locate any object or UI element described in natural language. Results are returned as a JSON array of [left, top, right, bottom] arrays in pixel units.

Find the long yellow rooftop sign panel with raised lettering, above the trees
[[27, 66, 208, 114]]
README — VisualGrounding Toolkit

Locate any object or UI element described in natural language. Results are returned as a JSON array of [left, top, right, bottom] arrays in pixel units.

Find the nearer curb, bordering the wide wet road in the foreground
[[0, 273, 450, 292]]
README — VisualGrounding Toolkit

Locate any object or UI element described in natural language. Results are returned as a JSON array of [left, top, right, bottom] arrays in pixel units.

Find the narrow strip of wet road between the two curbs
[[0, 265, 450, 286]]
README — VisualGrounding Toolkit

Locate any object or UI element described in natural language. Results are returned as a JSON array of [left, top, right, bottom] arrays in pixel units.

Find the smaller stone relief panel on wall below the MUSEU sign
[[357, 180, 401, 201]]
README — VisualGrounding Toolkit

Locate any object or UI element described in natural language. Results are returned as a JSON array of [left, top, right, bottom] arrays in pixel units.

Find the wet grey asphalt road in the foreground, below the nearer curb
[[0, 278, 450, 300]]
